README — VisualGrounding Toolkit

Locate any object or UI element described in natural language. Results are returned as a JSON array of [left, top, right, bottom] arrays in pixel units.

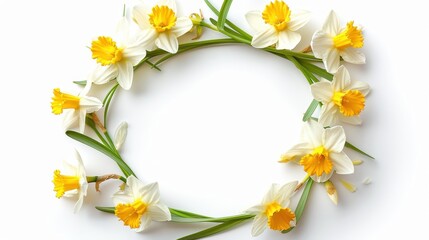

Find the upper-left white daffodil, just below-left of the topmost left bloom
[[89, 18, 146, 90]]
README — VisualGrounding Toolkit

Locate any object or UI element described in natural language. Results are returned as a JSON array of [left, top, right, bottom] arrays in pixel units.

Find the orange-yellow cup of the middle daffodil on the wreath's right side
[[332, 90, 365, 117]]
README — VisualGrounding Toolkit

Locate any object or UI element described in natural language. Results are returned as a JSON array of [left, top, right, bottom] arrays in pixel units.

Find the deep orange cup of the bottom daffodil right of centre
[[265, 202, 295, 231]]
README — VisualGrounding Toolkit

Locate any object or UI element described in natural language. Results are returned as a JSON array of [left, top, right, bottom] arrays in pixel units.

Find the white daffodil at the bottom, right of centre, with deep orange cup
[[246, 181, 298, 236]]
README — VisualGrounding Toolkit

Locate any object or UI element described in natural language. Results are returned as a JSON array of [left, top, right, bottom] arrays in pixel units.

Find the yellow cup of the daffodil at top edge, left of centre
[[149, 5, 177, 33]]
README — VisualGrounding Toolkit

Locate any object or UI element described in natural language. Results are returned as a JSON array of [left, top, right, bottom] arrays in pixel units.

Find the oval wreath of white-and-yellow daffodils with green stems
[[51, 0, 372, 239]]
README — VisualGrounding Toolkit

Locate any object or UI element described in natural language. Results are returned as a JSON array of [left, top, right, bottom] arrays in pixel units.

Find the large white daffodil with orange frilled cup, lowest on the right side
[[280, 120, 354, 182]]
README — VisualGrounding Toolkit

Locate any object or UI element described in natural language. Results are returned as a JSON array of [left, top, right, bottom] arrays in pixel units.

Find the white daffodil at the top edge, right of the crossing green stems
[[246, 0, 310, 50]]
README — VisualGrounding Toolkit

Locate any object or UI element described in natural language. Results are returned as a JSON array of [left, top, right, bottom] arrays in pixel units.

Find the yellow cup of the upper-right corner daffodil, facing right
[[334, 21, 363, 50]]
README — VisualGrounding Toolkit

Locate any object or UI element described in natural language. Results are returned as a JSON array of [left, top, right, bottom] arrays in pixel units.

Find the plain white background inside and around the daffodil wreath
[[0, 0, 429, 240]]
